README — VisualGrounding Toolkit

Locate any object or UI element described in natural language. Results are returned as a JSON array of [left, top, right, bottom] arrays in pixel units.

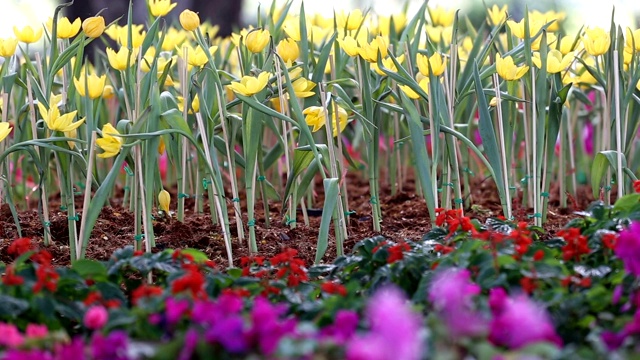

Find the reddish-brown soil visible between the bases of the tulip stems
[[0, 175, 593, 267]]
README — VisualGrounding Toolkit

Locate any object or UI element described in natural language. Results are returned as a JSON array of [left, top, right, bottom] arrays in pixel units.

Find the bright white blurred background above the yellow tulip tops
[[0, 0, 640, 37]]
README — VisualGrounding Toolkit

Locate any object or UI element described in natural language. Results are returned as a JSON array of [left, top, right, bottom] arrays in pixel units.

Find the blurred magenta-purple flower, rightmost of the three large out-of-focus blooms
[[489, 295, 562, 349]]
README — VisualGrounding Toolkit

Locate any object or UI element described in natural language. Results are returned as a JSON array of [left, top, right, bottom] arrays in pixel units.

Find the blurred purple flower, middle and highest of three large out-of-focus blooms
[[429, 269, 486, 337]]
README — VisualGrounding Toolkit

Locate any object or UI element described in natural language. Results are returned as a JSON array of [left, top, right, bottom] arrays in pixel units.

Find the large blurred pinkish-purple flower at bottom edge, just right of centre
[[347, 287, 424, 360]]
